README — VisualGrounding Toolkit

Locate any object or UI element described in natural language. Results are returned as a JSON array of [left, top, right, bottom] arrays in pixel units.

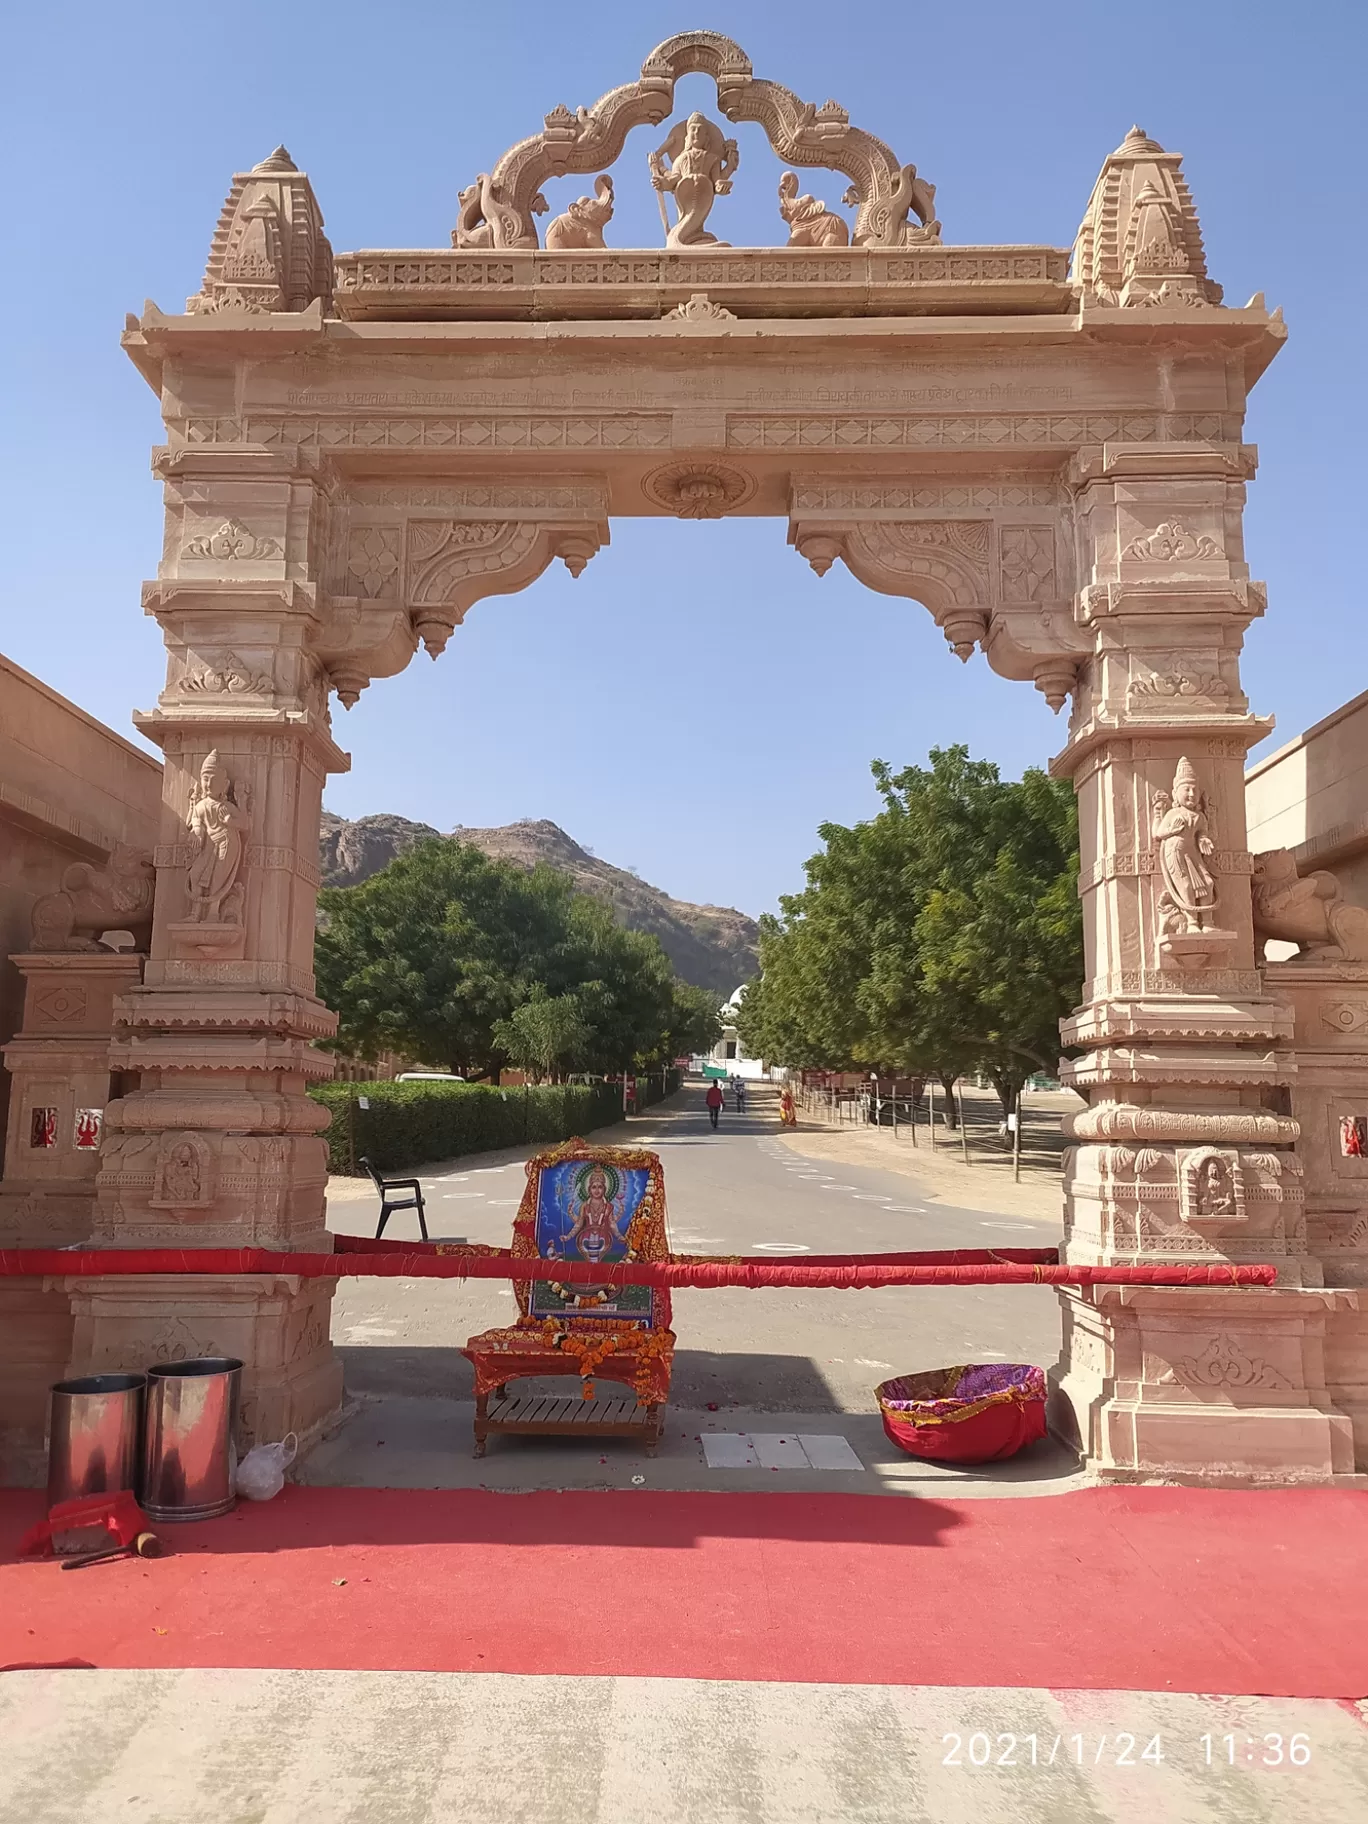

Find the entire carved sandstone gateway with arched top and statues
[[0, 31, 1368, 1481]]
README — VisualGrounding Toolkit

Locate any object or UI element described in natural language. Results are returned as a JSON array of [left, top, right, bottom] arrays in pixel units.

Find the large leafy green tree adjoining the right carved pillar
[[741, 748, 1083, 1107]]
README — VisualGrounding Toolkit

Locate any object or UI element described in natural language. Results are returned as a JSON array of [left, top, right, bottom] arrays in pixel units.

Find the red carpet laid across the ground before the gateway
[[0, 1488, 1368, 1698]]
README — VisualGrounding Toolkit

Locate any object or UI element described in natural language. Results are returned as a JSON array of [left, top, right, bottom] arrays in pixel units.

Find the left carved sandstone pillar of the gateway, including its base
[[82, 447, 353, 1443]]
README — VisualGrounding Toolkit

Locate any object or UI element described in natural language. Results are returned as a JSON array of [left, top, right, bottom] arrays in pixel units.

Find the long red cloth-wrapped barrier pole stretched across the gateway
[[0, 1242, 1277, 1291]]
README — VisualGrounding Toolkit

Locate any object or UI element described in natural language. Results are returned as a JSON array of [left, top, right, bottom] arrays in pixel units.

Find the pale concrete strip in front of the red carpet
[[0, 1671, 1368, 1824]]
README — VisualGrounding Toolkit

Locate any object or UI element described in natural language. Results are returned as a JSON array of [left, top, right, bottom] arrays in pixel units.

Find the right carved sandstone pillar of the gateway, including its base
[[1054, 445, 1353, 1481]]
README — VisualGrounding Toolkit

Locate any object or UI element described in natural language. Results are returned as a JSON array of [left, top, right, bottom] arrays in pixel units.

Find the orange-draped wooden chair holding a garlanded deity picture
[[461, 1140, 675, 1457]]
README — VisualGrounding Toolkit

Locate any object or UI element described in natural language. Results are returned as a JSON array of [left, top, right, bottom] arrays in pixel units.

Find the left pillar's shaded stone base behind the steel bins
[[62, 1273, 343, 1454]]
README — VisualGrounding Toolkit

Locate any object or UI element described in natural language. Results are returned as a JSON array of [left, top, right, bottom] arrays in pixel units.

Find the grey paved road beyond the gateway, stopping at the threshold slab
[[330, 1089, 1060, 1414]]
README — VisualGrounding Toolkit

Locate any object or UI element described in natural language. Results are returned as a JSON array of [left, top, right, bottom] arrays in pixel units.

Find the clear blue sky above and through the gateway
[[0, 0, 1368, 912]]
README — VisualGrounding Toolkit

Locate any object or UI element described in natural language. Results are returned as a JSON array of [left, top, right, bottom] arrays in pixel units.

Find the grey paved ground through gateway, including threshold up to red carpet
[[321, 1089, 1073, 1494]]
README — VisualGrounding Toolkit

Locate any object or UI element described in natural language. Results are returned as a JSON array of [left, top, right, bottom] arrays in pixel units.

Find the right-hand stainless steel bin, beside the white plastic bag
[[139, 1355, 243, 1521]]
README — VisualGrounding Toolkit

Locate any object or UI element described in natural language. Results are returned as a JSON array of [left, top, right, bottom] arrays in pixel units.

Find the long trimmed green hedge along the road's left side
[[308, 1076, 674, 1175]]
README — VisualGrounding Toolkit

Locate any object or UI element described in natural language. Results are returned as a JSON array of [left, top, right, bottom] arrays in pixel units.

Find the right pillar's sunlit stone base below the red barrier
[[1051, 1286, 1368, 1487]]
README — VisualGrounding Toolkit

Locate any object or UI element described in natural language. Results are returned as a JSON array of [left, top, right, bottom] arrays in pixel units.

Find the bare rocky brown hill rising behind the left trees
[[319, 810, 759, 994]]
